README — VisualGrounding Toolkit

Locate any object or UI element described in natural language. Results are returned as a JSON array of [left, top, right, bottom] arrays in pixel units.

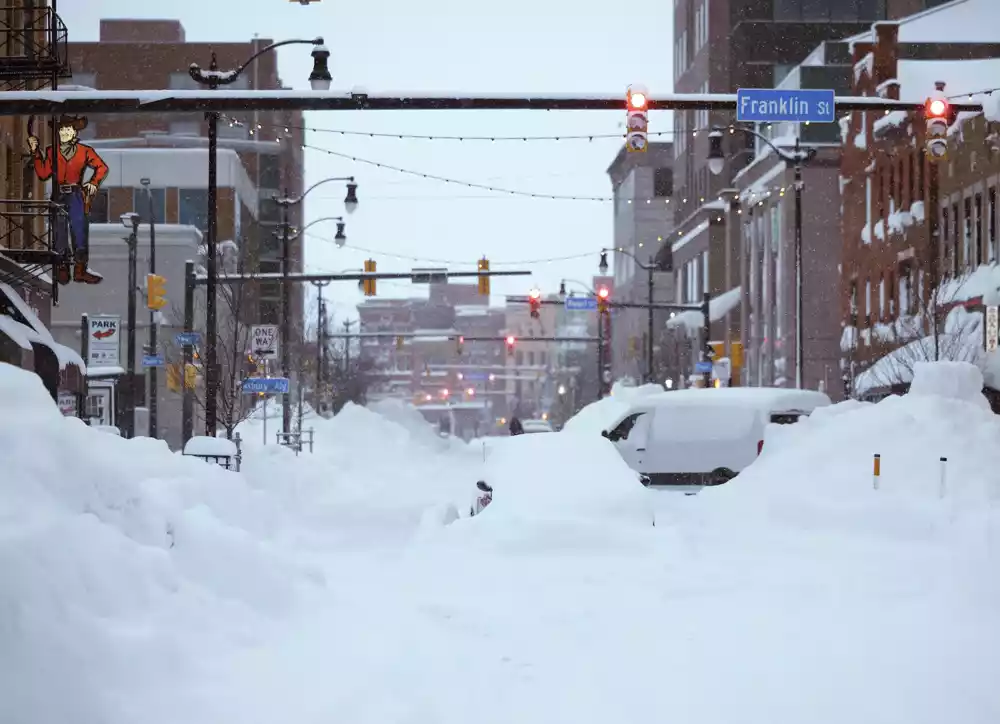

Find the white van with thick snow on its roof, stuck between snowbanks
[[601, 387, 830, 488]]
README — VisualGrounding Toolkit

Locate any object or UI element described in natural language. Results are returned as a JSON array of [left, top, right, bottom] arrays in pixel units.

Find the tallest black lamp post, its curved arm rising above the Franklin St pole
[[188, 38, 333, 437]]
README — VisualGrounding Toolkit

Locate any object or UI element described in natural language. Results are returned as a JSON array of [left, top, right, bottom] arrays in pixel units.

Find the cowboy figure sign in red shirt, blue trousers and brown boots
[[28, 116, 108, 284]]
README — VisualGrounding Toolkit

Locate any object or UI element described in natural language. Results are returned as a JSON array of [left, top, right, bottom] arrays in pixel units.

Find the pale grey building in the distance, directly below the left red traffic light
[[608, 143, 674, 380]]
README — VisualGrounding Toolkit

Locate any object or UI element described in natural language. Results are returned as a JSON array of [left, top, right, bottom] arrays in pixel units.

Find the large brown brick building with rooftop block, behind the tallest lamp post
[[69, 19, 305, 332]]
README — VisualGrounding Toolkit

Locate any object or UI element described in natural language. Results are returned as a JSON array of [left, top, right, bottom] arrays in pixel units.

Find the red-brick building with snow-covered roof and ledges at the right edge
[[840, 0, 1000, 395]]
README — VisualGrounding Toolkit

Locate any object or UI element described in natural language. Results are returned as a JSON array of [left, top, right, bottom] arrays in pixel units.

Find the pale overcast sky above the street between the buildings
[[58, 0, 673, 320]]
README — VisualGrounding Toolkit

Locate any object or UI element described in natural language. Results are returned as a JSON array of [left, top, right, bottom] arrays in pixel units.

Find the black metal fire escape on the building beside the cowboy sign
[[0, 0, 71, 303]]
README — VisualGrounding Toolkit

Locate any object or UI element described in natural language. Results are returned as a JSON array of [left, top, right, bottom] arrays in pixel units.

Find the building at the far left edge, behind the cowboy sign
[[0, 0, 82, 398]]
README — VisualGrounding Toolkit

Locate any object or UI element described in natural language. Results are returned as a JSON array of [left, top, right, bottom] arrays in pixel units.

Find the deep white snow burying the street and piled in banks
[[0, 365, 1000, 724]]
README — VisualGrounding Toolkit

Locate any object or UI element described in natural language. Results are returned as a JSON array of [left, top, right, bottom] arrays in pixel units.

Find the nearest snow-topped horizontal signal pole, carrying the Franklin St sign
[[0, 89, 982, 116]]
